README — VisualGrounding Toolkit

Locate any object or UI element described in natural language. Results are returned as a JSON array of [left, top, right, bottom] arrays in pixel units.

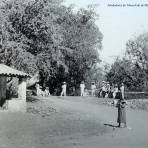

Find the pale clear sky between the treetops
[[64, 0, 148, 63]]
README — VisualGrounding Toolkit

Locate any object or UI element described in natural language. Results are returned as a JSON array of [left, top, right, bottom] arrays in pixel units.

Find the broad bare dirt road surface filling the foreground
[[0, 97, 148, 148]]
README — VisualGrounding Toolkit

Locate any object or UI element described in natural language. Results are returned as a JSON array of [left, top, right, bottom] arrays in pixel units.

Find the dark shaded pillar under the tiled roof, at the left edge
[[0, 76, 7, 107]]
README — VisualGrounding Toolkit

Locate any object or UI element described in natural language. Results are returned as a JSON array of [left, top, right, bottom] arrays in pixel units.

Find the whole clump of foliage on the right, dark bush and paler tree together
[[106, 33, 148, 91]]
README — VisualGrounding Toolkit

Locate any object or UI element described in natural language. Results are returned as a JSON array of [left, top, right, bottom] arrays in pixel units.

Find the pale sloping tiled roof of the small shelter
[[0, 64, 30, 77]]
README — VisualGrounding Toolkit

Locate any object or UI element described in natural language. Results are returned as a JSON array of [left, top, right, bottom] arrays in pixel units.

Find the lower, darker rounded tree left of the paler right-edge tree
[[106, 59, 143, 90]]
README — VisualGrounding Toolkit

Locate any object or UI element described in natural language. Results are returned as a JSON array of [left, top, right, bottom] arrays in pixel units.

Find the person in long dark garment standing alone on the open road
[[116, 92, 127, 127]]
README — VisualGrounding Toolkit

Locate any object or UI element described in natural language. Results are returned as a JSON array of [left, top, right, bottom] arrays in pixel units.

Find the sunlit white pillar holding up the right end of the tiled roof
[[18, 78, 26, 101]]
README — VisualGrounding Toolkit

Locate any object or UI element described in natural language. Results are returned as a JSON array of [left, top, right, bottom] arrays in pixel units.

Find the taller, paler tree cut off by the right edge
[[126, 33, 148, 89]]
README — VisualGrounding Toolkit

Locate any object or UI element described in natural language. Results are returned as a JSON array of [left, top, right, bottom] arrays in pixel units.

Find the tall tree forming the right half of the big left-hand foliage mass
[[57, 6, 103, 90]]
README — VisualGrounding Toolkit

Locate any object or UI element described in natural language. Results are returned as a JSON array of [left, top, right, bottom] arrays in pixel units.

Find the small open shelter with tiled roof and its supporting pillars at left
[[0, 64, 30, 111]]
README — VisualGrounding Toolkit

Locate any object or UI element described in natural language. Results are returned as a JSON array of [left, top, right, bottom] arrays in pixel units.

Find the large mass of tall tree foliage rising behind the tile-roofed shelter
[[0, 0, 102, 93]]
